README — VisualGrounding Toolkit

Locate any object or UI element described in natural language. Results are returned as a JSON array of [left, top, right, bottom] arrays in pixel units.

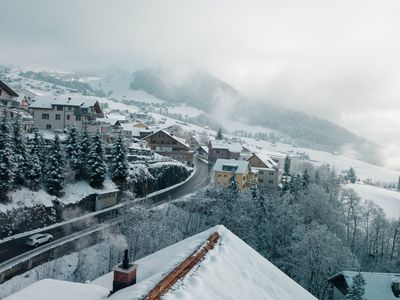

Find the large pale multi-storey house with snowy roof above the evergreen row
[[29, 96, 103, 130]]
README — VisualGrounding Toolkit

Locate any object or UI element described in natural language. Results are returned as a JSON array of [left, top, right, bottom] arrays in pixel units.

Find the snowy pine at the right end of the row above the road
[[110, 133, 128, 185]]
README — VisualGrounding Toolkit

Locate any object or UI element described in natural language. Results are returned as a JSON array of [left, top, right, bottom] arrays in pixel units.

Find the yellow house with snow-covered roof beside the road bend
[[213, 158, 257, 190]]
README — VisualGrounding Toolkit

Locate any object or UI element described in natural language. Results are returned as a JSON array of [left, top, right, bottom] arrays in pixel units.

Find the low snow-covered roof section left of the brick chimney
[[5, 279, 110, 300]]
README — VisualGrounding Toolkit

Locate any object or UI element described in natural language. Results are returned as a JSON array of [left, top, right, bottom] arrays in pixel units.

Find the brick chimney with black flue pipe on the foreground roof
[[112, 250, 138, 293]]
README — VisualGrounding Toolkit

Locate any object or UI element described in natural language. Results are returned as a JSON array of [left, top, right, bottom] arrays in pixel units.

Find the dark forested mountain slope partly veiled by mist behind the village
[[130, 69, 379, 163]]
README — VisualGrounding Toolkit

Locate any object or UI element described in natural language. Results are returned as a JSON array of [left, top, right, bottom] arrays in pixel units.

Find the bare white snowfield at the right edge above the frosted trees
[[344, 184, 400, 219]]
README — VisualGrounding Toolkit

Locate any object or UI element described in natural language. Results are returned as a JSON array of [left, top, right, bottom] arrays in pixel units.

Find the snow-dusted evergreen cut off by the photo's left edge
[[0, 108, 16, 202]]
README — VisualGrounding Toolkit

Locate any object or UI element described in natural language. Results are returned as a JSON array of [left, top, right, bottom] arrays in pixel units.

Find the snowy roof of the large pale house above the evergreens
[[29, 96, 97, 109]]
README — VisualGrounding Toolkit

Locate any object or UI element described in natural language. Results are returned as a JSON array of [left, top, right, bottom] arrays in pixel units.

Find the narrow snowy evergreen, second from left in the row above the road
[[13, 114, 27, 185]]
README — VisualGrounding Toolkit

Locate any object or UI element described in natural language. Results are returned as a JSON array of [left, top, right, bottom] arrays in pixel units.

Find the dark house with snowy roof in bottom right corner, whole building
[[328, 271, 400, 300]]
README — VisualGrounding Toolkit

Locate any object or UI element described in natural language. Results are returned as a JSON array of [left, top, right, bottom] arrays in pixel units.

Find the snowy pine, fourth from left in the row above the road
[[45, 134, 64, 196]]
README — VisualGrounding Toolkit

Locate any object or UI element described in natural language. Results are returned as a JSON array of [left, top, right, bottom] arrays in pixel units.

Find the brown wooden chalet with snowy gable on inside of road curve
[[143, 130, 193, 164]]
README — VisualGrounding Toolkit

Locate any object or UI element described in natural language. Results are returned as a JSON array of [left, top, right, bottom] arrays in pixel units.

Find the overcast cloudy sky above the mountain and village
[[0, 0, 400, 166]]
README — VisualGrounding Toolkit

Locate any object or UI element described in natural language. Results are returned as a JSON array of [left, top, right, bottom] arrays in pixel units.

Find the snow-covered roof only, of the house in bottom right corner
[[329, 271, 400, 300]]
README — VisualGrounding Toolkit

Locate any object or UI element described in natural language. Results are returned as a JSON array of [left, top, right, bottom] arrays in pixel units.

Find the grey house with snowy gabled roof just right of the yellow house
[[248, 153, 282, 189]]
